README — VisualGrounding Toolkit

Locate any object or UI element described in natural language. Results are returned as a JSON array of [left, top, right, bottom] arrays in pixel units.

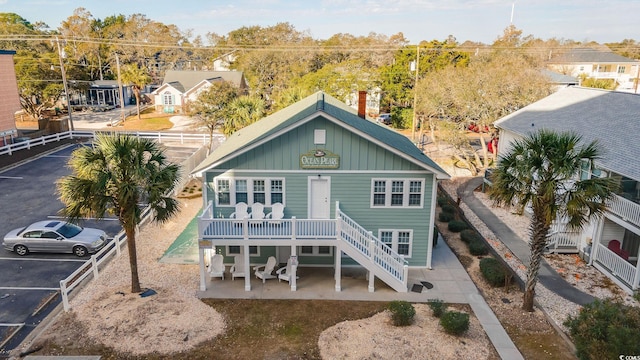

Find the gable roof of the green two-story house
[[193, 91, 449, 179]]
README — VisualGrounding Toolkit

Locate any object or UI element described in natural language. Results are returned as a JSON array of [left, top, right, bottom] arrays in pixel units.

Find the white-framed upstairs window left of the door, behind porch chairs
[[215, 177, 285, 206]]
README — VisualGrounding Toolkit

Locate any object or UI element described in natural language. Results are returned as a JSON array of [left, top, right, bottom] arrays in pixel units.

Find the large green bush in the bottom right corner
[[564, 299, 640, 359]]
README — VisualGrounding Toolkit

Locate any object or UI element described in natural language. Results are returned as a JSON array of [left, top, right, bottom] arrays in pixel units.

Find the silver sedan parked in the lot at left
[[2, 220, 107, 257]]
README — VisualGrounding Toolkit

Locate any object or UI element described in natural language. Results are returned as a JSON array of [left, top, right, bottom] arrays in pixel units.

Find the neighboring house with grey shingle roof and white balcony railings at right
[[495, 87, 640, 291]]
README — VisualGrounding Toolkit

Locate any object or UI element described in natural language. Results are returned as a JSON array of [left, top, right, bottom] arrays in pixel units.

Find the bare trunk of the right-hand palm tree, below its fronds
[[522, 211, 549, 312]]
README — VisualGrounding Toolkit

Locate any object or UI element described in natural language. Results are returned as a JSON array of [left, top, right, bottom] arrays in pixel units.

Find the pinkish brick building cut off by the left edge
[[0, 50, 22, 146]]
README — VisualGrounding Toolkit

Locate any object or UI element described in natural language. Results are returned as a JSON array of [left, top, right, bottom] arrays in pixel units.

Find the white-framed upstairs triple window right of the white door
[[371, 179, 424, 208]]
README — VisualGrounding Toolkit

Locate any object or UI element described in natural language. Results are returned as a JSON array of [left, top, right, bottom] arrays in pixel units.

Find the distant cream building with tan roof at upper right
[[547, 48, 640, 91]]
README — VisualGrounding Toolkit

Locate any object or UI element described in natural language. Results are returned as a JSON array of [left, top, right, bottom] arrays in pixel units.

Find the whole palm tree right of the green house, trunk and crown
[[490, 130, 616, 311]]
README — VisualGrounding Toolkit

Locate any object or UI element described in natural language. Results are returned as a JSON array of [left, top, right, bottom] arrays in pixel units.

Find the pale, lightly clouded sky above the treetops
[[0, 0, 640, 44]]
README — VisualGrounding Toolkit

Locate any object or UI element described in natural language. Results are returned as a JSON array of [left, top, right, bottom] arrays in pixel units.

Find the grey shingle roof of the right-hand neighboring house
[[494, 87, 640, 180]]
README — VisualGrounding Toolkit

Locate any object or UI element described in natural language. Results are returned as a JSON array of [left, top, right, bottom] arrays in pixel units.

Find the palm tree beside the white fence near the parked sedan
[[57, 134, 179, 293]]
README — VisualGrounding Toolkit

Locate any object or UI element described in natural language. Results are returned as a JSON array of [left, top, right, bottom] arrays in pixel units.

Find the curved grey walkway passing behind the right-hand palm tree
[[458, 177, 594, 305]]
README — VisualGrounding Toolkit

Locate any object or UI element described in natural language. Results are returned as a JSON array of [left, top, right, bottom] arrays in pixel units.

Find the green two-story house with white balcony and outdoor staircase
[[194, 92, 449, 292]]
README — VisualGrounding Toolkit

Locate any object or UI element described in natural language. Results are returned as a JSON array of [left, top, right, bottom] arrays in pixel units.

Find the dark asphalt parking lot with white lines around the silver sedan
[[0, 140, 201, 357]]
